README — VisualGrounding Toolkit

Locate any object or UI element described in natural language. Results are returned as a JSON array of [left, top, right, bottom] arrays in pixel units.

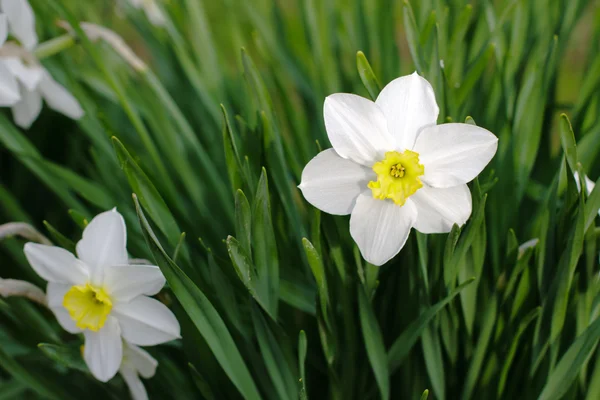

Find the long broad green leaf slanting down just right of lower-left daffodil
[[134, 195, 261, 400]]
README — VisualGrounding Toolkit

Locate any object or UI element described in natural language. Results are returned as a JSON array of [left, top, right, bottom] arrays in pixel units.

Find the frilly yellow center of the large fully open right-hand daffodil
[[369, 150, 425, 206]]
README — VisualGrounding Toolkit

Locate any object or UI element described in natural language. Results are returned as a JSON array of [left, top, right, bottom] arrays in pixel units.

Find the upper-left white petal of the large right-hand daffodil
[[324, 93, 394, 167]]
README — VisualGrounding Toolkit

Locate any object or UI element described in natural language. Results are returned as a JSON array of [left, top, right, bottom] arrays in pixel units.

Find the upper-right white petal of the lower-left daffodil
[[104, 265, 166, 303]]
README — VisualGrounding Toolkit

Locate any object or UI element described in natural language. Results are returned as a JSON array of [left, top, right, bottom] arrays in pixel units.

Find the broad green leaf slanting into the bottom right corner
[[538, 318, 600, 400]]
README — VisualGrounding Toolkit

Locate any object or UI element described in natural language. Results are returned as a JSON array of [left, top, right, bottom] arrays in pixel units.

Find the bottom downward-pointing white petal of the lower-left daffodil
[[83, 316, 123, 382]]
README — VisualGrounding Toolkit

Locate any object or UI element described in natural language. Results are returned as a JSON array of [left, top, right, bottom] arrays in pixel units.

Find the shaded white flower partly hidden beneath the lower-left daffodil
[[119, 341, 158, 400]]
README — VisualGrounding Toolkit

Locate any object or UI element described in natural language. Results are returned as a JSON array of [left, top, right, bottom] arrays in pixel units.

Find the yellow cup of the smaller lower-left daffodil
[[63, 283, 112, 332]]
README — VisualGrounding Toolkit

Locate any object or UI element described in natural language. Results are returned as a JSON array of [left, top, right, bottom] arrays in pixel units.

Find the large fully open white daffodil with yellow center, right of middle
[[299, 73, 498, 265]]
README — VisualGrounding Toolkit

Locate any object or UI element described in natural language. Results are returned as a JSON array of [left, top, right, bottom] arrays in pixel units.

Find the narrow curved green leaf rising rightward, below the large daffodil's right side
[[388, 278, 475, 373]]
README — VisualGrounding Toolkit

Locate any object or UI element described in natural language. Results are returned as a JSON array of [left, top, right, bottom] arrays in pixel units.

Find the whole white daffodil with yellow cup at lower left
[[25, 210, 180, 382]]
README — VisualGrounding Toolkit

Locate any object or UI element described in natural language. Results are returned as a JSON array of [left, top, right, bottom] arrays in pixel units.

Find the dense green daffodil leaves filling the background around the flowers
[[0, 0, 600, 400]]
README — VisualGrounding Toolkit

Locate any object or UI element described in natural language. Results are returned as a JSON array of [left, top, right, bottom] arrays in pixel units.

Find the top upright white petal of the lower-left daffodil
[[77, 210, 128, 285]]
